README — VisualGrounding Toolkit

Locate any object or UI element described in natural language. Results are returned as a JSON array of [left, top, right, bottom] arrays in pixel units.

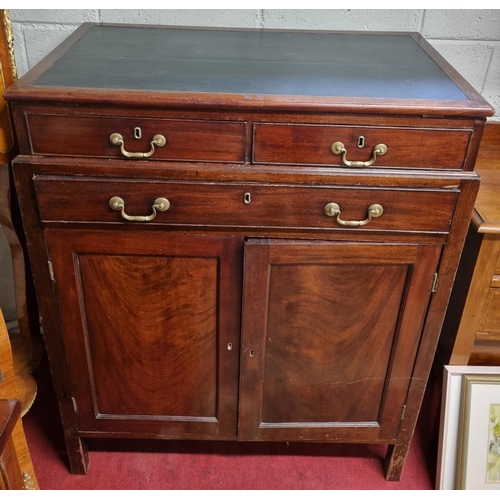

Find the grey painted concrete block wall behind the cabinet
[[0, 9, 500, 319]]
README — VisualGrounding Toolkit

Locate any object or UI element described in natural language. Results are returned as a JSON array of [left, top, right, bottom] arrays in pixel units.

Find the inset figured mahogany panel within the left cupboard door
[[78, 255, 218, 417]]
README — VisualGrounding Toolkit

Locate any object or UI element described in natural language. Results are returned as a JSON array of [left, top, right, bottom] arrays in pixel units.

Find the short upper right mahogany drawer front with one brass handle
[[253, 123, 470, 169]]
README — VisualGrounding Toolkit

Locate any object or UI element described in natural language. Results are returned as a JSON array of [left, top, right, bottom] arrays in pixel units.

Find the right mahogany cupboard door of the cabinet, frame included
[[238, 239, 441, 442]]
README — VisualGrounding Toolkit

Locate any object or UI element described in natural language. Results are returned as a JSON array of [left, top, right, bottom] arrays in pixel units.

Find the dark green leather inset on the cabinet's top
[[34, 25, 467, 100]]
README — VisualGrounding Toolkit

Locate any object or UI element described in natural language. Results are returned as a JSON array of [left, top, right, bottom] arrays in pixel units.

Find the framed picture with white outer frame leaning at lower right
[[436, 366, 500, 490]]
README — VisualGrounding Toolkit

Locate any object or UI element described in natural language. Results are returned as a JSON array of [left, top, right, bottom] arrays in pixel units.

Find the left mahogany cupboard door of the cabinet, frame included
[[46, 229, 243, 438]]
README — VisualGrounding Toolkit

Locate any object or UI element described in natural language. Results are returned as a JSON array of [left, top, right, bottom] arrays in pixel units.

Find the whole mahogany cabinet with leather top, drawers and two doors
[[6, 24, 493, 480]]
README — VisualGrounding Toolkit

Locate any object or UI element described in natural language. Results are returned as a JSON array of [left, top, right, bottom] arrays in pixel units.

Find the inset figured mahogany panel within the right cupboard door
[[262, 263, 408, 422]]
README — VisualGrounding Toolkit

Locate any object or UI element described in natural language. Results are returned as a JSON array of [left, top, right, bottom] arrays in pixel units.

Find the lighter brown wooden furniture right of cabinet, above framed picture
[[440, 123, 500, 366]]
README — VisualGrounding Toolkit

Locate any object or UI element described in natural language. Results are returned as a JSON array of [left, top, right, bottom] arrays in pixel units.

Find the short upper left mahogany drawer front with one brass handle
[[27, 114, 245, 163]]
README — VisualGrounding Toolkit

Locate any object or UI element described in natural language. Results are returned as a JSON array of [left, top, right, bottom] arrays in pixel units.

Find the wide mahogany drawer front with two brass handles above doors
[[35, 176, 458, 233]]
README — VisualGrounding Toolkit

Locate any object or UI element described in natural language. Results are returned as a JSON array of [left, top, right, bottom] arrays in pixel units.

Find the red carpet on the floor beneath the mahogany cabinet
[[23, 361, 435, 490]]
